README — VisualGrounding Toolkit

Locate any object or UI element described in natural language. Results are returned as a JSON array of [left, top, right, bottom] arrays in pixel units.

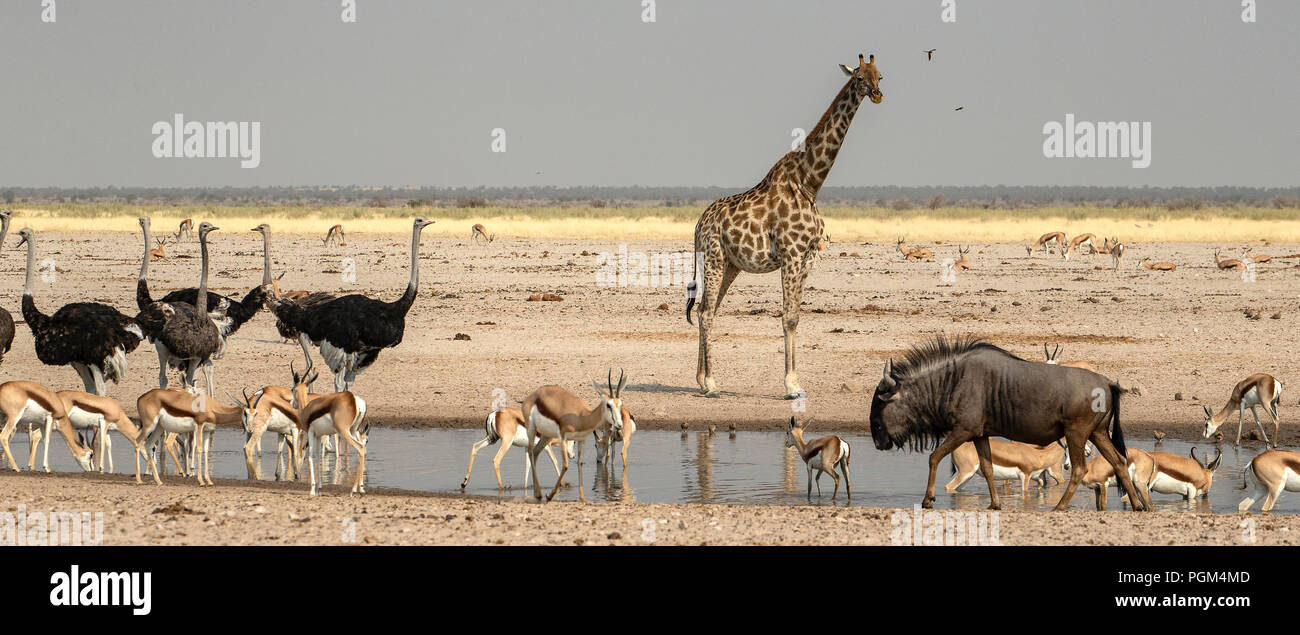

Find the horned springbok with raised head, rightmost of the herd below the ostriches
[[289, 362, 368, 496]]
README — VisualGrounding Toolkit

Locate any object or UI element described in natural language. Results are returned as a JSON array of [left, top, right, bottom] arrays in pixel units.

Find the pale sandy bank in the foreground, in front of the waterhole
[[0, 472, 1300, 545]]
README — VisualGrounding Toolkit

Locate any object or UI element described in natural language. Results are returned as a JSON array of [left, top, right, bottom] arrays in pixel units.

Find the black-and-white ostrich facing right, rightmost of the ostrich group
[[272, 217, 433, 392]]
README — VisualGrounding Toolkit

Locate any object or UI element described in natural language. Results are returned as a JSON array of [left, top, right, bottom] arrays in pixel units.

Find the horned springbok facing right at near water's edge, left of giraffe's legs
[[523, 370, 628, 502]]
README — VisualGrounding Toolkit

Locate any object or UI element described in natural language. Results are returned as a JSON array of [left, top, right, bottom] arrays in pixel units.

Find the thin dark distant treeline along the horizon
[[0, 185, 1300, 209]]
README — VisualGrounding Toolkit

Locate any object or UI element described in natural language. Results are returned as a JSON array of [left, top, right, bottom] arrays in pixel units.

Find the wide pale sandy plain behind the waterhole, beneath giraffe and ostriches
[[0, 226, 1300, 444]]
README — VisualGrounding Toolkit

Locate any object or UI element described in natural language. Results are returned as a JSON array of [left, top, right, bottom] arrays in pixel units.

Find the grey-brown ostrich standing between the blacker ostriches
[[135, 223, 226, 397]]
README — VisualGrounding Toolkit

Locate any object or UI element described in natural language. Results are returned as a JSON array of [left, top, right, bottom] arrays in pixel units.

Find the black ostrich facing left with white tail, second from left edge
[[18, 228, 144, 396]]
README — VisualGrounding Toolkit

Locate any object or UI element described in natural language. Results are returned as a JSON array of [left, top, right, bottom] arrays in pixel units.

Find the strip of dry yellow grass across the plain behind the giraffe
[[13, 204, 1300, 245]]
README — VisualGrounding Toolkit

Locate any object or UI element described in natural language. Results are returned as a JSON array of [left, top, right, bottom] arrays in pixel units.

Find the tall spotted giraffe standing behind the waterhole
[[686, 55, 884, 399]]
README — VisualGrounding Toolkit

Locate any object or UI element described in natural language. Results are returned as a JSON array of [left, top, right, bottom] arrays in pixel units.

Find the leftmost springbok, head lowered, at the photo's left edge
[[0, 381, 94, 472]]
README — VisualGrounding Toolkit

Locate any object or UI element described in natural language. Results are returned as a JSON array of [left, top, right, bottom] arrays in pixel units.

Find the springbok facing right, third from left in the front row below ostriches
[[135, 388, 243, 487]]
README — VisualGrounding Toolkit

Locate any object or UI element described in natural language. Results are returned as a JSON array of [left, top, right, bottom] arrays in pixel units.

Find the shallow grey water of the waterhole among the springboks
[[22, 427, 1300, 513]]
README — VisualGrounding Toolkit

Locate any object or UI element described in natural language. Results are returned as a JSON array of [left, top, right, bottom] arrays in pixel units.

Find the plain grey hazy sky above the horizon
[[0, 0, 1300, 187]]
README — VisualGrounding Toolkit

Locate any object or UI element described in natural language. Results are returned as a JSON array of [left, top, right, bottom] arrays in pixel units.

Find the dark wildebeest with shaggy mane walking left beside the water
[[871, 337, 1151, 510]]
